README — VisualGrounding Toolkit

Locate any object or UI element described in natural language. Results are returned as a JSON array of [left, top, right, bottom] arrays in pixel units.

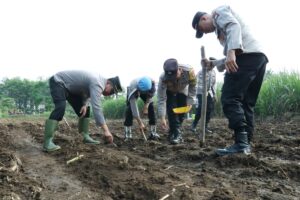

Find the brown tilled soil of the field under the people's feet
[[0, 119, 300, 200]]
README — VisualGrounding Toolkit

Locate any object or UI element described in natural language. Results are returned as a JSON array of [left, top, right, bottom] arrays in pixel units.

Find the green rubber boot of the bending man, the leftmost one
[[43, 119, 60, 152]]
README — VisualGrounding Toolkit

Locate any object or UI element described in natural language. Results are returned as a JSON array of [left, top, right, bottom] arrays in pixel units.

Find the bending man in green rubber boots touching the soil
[[43, 70, 122, 152]]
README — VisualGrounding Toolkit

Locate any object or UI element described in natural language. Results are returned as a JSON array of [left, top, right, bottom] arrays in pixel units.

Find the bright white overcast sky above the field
[[0, 0, 300, 87]]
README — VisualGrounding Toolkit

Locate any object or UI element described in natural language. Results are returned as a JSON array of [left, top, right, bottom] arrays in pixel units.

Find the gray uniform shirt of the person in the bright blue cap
[[127, 78, 155, 118]]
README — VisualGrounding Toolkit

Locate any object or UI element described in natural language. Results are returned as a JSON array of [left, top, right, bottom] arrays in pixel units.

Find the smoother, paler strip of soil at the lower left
[[9, 124, 103, 200]]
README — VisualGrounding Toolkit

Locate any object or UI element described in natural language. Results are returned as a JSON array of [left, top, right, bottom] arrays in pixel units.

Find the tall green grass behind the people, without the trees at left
[[0, 71, 300, 119]]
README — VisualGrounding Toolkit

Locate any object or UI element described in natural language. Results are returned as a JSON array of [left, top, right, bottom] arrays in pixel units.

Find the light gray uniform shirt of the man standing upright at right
[[212, 5, 262, 71]]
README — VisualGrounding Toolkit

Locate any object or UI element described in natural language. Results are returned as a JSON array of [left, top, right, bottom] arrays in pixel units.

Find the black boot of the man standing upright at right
[[216, 132, 251, 156]]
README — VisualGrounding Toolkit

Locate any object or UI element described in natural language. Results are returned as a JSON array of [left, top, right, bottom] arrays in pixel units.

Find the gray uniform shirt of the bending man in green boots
[[54, 70, 107, 126]]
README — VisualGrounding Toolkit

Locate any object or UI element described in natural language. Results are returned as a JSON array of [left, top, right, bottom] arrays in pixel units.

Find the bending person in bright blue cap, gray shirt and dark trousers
[[124, 76, 159, 140]]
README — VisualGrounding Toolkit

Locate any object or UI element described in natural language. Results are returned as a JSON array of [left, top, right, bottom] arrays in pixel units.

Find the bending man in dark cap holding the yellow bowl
[[157, 58, 197, 144]]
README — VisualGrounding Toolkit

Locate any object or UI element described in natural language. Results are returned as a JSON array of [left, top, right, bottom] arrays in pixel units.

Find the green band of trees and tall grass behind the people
[[0, 71, 300, 119]]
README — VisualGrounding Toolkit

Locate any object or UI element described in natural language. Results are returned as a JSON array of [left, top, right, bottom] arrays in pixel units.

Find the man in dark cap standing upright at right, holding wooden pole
[[192, 5, 268, 156]]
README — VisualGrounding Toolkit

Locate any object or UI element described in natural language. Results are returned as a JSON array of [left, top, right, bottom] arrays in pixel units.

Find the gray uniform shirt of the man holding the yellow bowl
[[157, 64, 197, 117]]
